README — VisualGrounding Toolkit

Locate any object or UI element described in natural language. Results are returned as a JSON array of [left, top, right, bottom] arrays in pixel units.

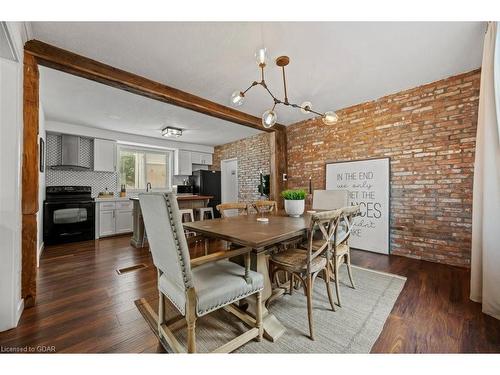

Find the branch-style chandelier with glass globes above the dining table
[[231, 48, 339, 128]]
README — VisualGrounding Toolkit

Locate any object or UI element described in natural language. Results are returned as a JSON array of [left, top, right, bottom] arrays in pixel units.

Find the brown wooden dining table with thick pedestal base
[[184, 212, 311, 341]]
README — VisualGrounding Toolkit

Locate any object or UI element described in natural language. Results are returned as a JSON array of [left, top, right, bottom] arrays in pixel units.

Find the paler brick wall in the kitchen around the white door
[[211, 133, 271, 207]]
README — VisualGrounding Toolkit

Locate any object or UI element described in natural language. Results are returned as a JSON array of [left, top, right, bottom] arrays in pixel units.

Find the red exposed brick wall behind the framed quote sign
[[287, 70, 480, 266]]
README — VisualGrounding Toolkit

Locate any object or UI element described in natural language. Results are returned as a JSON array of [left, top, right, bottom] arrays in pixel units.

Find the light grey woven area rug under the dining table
[[136, 266, 406, 353]]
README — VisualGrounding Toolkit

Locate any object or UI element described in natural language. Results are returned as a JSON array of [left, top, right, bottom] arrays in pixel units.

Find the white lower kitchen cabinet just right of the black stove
[[96, 200, 133, 238]]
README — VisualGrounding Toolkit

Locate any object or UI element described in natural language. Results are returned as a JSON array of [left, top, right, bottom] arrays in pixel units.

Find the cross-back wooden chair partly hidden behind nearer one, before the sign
[[313, 205, 360, 306]]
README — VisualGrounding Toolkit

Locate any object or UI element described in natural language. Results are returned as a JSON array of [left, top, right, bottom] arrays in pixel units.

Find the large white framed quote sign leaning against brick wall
[[326, 158, 390, 254]]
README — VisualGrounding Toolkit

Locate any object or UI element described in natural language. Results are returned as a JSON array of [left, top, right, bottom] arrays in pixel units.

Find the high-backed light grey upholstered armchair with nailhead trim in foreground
[[139, 193, 264, 353]]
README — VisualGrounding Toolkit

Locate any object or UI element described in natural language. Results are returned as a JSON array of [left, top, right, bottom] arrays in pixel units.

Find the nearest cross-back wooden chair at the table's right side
[[270, 210, 342, 340]]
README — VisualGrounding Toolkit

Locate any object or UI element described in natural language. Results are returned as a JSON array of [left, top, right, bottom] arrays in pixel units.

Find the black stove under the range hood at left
[[43, 186, 95, 245]]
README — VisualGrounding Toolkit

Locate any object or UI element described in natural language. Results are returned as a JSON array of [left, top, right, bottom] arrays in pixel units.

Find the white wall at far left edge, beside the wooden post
[[0, 22, 28, 331]]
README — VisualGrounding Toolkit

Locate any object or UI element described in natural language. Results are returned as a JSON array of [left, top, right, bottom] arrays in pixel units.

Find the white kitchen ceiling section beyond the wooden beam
[[40, 67, 259, 146]]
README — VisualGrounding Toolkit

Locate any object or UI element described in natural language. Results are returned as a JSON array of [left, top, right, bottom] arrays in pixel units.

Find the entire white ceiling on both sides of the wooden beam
[[32, 22, 485, 145]]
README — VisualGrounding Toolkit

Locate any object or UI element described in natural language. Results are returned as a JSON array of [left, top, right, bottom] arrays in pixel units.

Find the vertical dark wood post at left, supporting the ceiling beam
[[21, 53, 39, 307]]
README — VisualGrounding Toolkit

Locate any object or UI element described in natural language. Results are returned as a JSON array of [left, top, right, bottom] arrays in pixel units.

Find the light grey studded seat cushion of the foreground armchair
[[192, 260, 264, 316]]
